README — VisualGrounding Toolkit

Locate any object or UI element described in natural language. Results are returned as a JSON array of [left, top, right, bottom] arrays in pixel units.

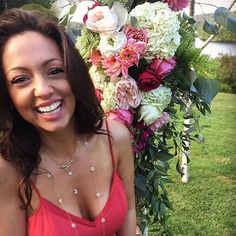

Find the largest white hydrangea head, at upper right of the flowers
[[130, 2, 180, 61]]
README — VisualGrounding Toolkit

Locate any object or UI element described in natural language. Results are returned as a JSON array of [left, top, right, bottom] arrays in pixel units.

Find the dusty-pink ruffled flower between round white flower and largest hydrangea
[[124, 25, 148, 43]]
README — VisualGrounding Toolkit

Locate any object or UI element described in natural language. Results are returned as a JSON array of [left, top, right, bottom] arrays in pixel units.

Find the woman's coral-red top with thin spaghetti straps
[[28, 121, 128, 236]]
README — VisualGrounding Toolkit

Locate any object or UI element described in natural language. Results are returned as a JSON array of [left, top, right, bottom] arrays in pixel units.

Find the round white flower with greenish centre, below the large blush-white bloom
[[98, 32, 127, 57]]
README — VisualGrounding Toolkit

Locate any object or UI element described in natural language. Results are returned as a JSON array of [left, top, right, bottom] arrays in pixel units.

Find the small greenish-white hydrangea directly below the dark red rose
[[141, 86, 172, 112]]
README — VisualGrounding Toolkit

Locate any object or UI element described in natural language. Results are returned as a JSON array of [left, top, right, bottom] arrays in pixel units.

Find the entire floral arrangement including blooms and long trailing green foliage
[[20, 0, 221, 234]]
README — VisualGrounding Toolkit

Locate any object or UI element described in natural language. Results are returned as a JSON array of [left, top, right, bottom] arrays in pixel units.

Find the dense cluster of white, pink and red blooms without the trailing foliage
[[71, 1, 181, 153]]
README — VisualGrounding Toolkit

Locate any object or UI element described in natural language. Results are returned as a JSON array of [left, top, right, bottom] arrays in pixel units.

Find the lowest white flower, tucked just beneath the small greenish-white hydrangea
[[139, 105, 162, 126]]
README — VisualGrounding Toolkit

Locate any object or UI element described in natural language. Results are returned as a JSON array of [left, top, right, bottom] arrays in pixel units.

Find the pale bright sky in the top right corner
[[186, 0, 236, 15]]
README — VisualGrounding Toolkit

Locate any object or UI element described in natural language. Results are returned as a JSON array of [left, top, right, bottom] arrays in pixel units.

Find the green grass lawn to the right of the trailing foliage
[[166, 93, 236, 236]]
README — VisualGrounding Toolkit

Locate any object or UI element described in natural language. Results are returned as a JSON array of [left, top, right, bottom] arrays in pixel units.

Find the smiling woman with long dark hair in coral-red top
[[0, 9, 136, 236]]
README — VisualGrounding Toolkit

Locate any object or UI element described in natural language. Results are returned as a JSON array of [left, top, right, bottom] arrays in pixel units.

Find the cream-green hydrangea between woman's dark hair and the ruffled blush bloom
[[101, 82, 118, 112]]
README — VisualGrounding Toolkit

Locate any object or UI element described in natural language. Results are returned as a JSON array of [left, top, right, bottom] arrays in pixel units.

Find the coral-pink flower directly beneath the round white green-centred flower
[[102, 56, 121, 78]]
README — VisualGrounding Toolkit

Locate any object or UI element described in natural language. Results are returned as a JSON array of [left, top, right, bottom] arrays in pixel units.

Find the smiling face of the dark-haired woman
[[3, 31, 75, 132]]
